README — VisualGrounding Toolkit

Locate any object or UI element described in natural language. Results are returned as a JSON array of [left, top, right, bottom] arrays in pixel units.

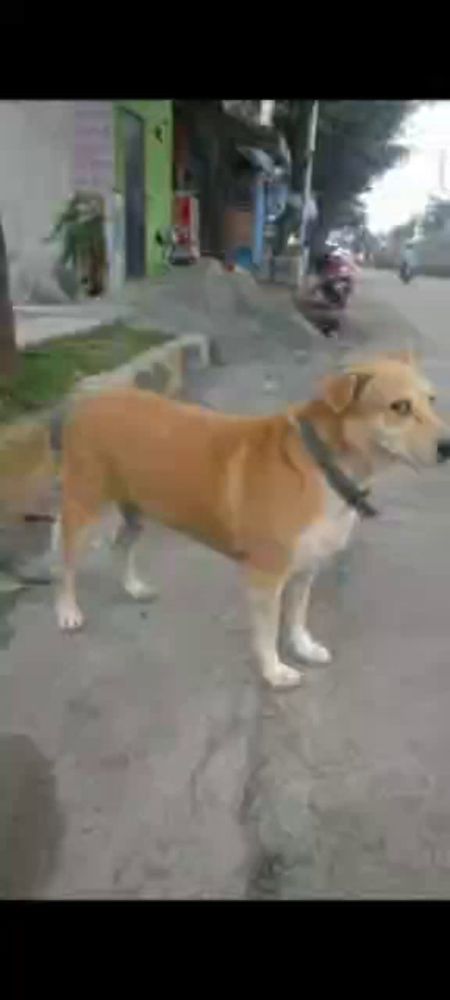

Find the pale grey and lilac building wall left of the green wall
[[0, 101, 120, 303]]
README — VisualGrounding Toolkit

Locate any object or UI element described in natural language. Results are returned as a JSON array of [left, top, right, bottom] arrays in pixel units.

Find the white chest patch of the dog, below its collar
[[294, 487, 357, 570]]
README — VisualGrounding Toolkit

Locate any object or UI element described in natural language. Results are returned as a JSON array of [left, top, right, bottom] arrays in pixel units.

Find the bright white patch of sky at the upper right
[[365, 101, 450, 233]]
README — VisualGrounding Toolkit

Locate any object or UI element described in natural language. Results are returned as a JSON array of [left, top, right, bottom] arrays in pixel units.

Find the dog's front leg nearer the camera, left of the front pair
[[246, 571, 301, 688]]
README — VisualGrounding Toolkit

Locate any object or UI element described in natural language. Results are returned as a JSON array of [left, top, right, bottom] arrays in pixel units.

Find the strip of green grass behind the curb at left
[[0, 323, 170, 422]]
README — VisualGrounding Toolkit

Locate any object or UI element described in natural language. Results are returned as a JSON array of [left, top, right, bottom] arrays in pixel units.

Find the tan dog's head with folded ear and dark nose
[[321, 353, 450, 468]]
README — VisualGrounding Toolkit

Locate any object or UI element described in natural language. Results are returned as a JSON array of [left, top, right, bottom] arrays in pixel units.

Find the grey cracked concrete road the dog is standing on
[[4, 273, 450, 899]]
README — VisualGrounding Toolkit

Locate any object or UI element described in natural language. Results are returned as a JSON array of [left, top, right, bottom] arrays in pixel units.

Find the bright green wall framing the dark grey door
[[115, 101, 173, 275]]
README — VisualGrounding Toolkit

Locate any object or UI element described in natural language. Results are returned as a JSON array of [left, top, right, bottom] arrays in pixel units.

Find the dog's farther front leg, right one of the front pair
[[283, 572, 331, 663]]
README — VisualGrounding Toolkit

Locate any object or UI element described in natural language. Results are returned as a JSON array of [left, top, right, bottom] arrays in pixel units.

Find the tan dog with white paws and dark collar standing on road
[[53, 356, 450, 687]]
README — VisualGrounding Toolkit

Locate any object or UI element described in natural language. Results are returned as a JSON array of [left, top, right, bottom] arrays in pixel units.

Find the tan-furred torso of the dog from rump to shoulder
[[62, 389, 321, 573]]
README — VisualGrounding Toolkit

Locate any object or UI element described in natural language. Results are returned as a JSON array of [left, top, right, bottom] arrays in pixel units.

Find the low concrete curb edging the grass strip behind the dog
[[0, 333, 211, 522]]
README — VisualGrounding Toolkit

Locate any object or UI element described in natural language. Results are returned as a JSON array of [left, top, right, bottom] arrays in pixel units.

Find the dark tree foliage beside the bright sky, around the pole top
[[275, 100, 414, 249]]
